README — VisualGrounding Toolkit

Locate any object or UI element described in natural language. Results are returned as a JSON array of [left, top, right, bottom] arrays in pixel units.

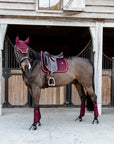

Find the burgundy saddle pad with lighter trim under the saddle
[[40, 51, 68, 73]]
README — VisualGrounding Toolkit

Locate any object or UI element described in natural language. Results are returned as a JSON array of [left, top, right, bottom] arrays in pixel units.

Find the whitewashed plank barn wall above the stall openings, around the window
[[0, 0, 114, 113]]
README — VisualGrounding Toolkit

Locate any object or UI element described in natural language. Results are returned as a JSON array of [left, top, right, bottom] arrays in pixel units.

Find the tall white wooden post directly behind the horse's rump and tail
[[90, 22, 103, 114]]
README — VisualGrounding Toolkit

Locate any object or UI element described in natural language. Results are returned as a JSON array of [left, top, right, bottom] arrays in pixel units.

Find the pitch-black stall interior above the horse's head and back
[[7, 25, 91, 57]]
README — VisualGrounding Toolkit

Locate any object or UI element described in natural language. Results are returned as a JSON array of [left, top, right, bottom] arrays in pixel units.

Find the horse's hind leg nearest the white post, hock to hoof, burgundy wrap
[[86, 87, 99, 124]]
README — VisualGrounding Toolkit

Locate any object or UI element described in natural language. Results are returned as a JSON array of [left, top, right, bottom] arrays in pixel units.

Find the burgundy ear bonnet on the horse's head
[[16, 36, 29, 53]]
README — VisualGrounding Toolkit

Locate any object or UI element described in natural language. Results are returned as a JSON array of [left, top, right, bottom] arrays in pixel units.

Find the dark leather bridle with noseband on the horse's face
[[14, 45, 30, 69]]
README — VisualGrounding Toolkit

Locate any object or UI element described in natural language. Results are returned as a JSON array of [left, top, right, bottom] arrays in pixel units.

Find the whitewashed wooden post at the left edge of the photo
[[0, 24, 7, 116]]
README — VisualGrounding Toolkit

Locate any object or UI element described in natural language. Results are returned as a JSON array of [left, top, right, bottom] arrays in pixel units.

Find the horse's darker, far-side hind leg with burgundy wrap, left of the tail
[[75, 83, 86, 121]]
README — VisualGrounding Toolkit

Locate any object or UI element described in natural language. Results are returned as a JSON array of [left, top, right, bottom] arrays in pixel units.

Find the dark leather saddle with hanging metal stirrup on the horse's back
[[43, 51, 63, 86]]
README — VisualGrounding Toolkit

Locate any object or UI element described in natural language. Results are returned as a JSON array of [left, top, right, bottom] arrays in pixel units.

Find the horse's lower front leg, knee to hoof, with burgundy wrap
[[29, 87, 41, 130]]
